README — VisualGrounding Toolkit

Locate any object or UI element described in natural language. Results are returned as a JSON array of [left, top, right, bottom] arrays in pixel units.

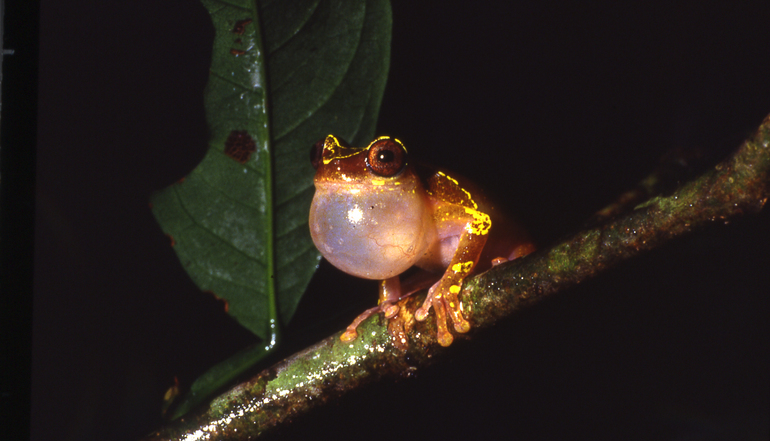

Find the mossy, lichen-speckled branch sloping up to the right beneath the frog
[[141, 116, 770, 440]]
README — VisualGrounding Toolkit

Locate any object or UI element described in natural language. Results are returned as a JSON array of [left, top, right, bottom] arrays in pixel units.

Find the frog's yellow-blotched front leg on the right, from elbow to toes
[[414, 207, 492, 346]]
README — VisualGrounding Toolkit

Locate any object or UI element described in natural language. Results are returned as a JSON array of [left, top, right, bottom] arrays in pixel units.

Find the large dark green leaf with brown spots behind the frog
[[152, 0, 391, 340]]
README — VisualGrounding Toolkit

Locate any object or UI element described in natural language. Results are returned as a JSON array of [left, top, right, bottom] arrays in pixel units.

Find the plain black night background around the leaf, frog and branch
[[25, 0, 770, 440]]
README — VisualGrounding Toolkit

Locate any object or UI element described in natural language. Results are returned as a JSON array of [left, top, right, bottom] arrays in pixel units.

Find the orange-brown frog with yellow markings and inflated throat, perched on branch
[[309, 135, 534, 346]]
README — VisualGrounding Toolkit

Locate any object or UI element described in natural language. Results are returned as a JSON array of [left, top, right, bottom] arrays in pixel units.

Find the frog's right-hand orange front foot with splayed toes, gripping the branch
[[414, 279, 471, 346]]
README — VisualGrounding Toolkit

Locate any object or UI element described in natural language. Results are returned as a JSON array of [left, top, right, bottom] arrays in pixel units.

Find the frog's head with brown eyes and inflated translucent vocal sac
[[310, 135, 435, 279]]
